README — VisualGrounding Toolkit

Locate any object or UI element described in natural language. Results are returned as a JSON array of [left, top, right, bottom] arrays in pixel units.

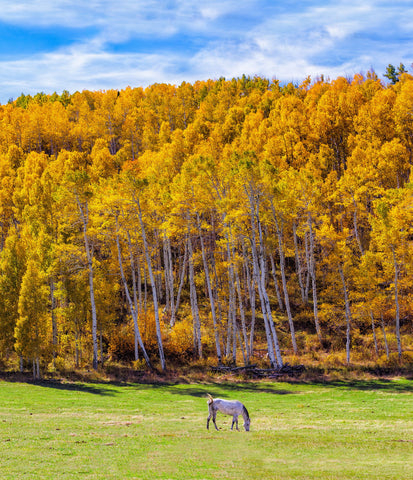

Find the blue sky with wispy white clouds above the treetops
[[0, 0, 413, 104]]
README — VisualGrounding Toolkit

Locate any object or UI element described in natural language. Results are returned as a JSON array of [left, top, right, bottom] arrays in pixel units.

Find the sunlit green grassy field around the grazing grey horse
[[0, 379, 413, 480]]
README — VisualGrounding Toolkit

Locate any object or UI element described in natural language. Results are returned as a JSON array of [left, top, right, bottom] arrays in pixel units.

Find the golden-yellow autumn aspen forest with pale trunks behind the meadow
[[0, 71, 413, 377]]
